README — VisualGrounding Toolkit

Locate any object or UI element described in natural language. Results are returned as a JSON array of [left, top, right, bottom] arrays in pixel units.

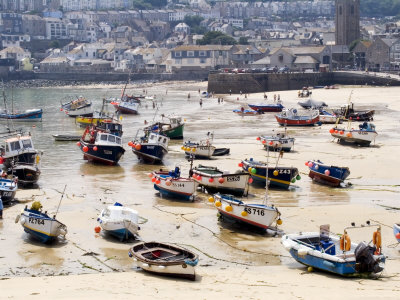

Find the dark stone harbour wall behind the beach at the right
[[208, 71, 400, 94]]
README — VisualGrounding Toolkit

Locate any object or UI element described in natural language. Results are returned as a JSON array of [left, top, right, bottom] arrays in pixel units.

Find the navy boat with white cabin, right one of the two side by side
[[128, 130, 169, 164]]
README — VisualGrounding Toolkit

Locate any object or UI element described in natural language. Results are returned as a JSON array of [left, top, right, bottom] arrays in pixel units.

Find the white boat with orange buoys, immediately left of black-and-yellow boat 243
[[192, 165, 250, 196]]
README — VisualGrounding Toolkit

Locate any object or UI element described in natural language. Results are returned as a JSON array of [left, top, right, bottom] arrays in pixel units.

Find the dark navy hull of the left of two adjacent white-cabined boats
[[79, 139, 125, 165]]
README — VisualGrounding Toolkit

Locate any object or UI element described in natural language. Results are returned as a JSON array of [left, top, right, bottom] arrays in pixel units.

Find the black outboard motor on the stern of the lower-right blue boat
[[354, 242, 383, 273]]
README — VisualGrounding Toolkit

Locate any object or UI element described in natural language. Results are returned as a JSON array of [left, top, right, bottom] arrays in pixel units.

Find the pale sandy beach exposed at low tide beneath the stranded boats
[[0, 83, 400, 299]]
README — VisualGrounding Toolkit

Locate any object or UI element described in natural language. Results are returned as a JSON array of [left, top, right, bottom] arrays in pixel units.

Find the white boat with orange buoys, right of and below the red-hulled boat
[[329, 122, 378, 146]]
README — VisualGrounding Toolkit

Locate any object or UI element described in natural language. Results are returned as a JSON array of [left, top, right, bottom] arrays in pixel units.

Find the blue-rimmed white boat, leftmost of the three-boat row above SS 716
[[151, 167, 198, 201]]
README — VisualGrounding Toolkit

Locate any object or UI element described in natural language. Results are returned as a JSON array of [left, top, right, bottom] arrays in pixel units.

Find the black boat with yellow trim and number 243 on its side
[[239, 158, 301, 190]]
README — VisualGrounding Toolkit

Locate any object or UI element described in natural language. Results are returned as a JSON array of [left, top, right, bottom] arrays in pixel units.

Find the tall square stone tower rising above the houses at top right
[[335, 0, 360, 45]]
